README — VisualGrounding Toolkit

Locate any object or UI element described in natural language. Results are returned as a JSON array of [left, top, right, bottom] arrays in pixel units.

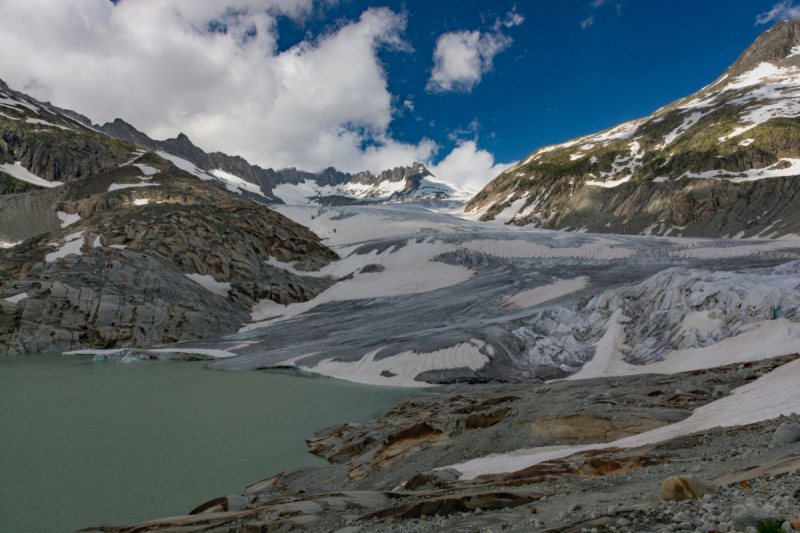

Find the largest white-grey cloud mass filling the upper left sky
[[0, 0, 450, 176]]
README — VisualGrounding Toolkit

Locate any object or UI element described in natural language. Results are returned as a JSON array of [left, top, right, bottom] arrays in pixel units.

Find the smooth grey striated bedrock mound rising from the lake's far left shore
[[0, 248, 248, 354]]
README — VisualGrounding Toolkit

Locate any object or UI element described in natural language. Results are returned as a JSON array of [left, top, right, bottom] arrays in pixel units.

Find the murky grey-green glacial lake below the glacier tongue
[[0, 354, 416, 533]]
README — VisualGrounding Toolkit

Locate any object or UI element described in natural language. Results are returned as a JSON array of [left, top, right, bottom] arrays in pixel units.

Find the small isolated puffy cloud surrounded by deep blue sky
[[426, 11, 525, 93]]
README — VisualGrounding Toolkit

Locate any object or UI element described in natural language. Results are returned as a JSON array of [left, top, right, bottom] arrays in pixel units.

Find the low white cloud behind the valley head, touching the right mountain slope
[[429, 141, 517, 191]]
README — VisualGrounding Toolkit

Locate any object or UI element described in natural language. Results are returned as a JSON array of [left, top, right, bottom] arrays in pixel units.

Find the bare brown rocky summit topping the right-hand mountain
[[725, 19, 800, 77]]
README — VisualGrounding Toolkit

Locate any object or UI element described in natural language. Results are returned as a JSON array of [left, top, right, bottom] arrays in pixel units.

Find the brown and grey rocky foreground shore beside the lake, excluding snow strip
[[85, 356, 800, 533]]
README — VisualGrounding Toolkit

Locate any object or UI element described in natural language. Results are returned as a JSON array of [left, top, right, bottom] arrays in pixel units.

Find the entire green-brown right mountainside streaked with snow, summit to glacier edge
[[466, 20, 800, 238]]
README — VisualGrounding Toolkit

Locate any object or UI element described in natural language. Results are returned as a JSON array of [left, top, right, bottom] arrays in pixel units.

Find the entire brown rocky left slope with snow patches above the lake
[[0, 86, 337, 354]]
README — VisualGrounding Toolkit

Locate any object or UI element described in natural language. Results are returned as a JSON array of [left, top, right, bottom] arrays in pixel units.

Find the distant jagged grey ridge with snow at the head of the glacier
[[96, 119, 475, 205]]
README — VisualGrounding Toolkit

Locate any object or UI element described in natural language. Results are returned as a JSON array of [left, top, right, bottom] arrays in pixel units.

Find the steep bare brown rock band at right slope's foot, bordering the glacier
[[496, 177, 800, 238]]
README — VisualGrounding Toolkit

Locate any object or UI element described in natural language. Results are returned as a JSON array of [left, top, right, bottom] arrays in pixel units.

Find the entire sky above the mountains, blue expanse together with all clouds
[[0, 0, 800, 188]]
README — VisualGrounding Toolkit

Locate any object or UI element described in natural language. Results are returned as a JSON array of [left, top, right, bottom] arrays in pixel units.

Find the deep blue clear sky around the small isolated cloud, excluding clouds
[[279, 0, 792, 166]]
